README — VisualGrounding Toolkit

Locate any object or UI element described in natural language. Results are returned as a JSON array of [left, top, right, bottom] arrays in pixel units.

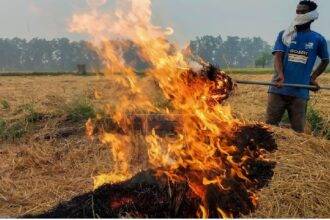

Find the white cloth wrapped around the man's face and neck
[[282, 10, 319, 46]]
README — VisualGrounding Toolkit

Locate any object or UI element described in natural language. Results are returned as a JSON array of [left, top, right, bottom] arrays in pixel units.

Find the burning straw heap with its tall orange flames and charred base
[[23, 0, 276, 217]]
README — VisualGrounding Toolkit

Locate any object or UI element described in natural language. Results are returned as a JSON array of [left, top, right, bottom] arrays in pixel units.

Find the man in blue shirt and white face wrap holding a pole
[[266, 0, 329, 132]]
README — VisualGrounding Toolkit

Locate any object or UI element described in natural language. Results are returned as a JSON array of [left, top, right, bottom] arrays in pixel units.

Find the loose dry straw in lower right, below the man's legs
[[252, 128, 330, 218]]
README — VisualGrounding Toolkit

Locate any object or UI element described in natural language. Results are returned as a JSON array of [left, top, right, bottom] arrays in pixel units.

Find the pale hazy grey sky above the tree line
[[0, 0, 330, 44]]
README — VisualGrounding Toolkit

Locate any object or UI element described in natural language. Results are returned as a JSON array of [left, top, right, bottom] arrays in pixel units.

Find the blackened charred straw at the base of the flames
[[25, 125, 276, 218]]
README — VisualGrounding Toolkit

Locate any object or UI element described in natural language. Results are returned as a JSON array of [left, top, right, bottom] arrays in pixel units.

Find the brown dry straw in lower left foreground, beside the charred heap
[[0, 137, 111, 217]]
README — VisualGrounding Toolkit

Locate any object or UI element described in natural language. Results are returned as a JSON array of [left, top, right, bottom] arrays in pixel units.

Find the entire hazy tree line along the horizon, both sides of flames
[[0, 36, 330, 72]]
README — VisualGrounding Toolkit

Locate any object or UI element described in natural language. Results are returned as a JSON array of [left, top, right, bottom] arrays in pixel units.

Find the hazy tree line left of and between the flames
[[0, 38, 147, 73]]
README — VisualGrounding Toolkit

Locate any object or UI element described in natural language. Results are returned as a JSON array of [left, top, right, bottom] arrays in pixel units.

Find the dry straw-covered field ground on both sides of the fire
[[0, 73, 330, 218]]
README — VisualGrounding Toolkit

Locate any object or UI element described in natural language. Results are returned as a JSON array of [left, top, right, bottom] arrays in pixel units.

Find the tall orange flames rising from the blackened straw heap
[[70, 0, 274, 218]]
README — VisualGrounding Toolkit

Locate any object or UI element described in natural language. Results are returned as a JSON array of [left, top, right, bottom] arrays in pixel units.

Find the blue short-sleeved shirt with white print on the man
[[269, 31, 329, 100]]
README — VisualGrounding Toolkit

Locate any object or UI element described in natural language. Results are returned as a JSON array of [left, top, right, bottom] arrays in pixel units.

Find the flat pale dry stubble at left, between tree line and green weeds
[[0, 75, 104, 114]]
